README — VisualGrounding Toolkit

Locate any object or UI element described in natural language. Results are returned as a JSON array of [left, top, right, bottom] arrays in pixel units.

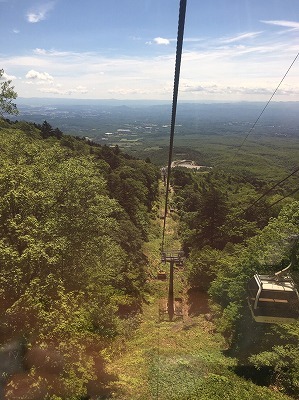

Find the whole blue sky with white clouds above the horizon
[[0, 0, 299, 102]]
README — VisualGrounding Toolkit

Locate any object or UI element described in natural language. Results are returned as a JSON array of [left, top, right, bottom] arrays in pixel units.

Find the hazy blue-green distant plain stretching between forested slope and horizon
[[17, 99, 299, 180]]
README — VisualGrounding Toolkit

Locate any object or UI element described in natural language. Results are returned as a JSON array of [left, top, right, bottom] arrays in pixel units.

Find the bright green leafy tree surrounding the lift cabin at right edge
[[209, 201, 299, 348]]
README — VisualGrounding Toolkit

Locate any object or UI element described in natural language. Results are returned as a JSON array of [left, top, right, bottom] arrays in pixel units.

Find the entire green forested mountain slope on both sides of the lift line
[[0, 120, 299, 400]]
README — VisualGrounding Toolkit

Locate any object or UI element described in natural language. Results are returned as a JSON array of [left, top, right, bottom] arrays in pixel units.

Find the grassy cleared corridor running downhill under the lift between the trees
[[105, 187, 289, 400]]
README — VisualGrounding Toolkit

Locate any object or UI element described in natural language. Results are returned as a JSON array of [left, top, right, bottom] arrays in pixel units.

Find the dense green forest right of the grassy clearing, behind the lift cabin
[[172, 169, 299, 398]]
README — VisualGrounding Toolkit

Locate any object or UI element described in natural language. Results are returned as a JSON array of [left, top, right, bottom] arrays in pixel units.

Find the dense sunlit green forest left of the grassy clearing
[[0, 120, 159, 398]]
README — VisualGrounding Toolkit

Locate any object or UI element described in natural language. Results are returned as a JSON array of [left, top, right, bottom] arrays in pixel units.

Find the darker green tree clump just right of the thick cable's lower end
[[172, 169, 271, 253]]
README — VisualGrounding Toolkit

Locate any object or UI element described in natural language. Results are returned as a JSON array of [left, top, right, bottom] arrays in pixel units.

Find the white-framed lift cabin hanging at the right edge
[[248, 274, 299, 323]]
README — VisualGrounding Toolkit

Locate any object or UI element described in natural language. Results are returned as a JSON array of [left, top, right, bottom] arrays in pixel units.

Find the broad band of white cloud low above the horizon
[[0, 33, 299, 101]]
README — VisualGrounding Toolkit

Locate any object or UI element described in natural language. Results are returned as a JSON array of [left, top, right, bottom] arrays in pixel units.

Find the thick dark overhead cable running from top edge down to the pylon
[[162, 0, 187, 251]]
